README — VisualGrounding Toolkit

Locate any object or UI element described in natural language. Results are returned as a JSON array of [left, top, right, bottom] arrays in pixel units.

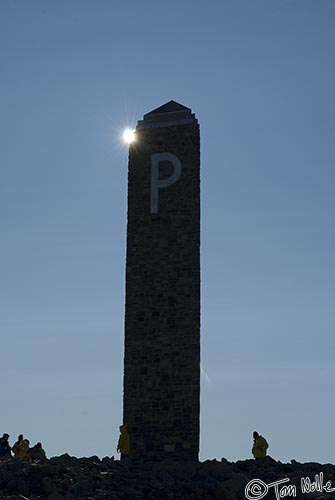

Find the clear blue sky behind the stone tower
[[0, 0, 335, 462]]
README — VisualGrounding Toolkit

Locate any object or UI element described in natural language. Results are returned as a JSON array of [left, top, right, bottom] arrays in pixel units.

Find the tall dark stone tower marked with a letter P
[[123, 101, 200, 460]]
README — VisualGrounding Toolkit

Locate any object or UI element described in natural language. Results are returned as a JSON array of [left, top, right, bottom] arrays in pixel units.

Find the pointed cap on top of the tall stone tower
[[136, 101, 197, 130]]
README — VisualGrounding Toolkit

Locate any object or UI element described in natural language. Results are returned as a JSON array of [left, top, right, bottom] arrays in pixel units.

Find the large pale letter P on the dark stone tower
[[150, 153, 181, 214]]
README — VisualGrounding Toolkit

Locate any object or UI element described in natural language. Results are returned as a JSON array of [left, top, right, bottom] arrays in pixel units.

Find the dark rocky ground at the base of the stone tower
[[0, 455, 335, 500]]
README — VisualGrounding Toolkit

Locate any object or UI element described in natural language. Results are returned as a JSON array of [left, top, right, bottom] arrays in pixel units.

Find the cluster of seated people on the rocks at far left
[[0, 432, 47, 462]]
